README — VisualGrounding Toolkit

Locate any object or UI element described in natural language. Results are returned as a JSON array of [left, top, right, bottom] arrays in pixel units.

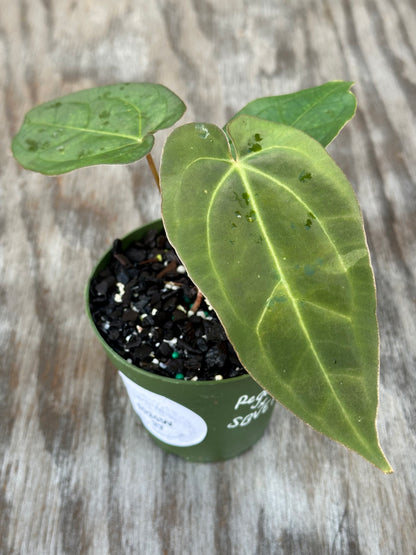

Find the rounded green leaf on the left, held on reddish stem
[[12, 83, 185, 175]]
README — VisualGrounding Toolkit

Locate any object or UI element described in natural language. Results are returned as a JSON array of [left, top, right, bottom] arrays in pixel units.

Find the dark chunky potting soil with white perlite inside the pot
[[90, 230, 246, 380]]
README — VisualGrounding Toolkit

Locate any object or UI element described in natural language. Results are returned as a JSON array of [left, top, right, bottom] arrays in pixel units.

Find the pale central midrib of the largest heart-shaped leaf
[[237, 164, 368, 452]]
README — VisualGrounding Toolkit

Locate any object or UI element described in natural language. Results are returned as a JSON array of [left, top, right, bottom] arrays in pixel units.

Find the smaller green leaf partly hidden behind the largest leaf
[[229, 81, 357, 146]]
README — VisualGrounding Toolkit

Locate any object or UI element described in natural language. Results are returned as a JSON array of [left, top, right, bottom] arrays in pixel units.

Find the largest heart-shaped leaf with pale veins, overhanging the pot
[[161, 116, 391, 472]]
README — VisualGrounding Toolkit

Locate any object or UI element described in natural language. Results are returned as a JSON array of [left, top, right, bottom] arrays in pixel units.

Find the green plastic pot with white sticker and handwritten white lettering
[[86, 220, 274, 462]]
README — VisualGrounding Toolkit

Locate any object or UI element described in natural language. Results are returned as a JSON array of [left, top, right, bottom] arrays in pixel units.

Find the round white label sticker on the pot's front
[[119, 371, 208, 447]]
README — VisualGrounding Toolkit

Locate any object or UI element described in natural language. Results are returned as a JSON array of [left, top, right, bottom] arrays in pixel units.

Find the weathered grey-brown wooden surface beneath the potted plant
[[0, 0, 416, 555]]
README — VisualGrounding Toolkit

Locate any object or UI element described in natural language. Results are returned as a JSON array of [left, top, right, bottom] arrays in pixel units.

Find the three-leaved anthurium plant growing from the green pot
[[12, 81, 391, 473]]
